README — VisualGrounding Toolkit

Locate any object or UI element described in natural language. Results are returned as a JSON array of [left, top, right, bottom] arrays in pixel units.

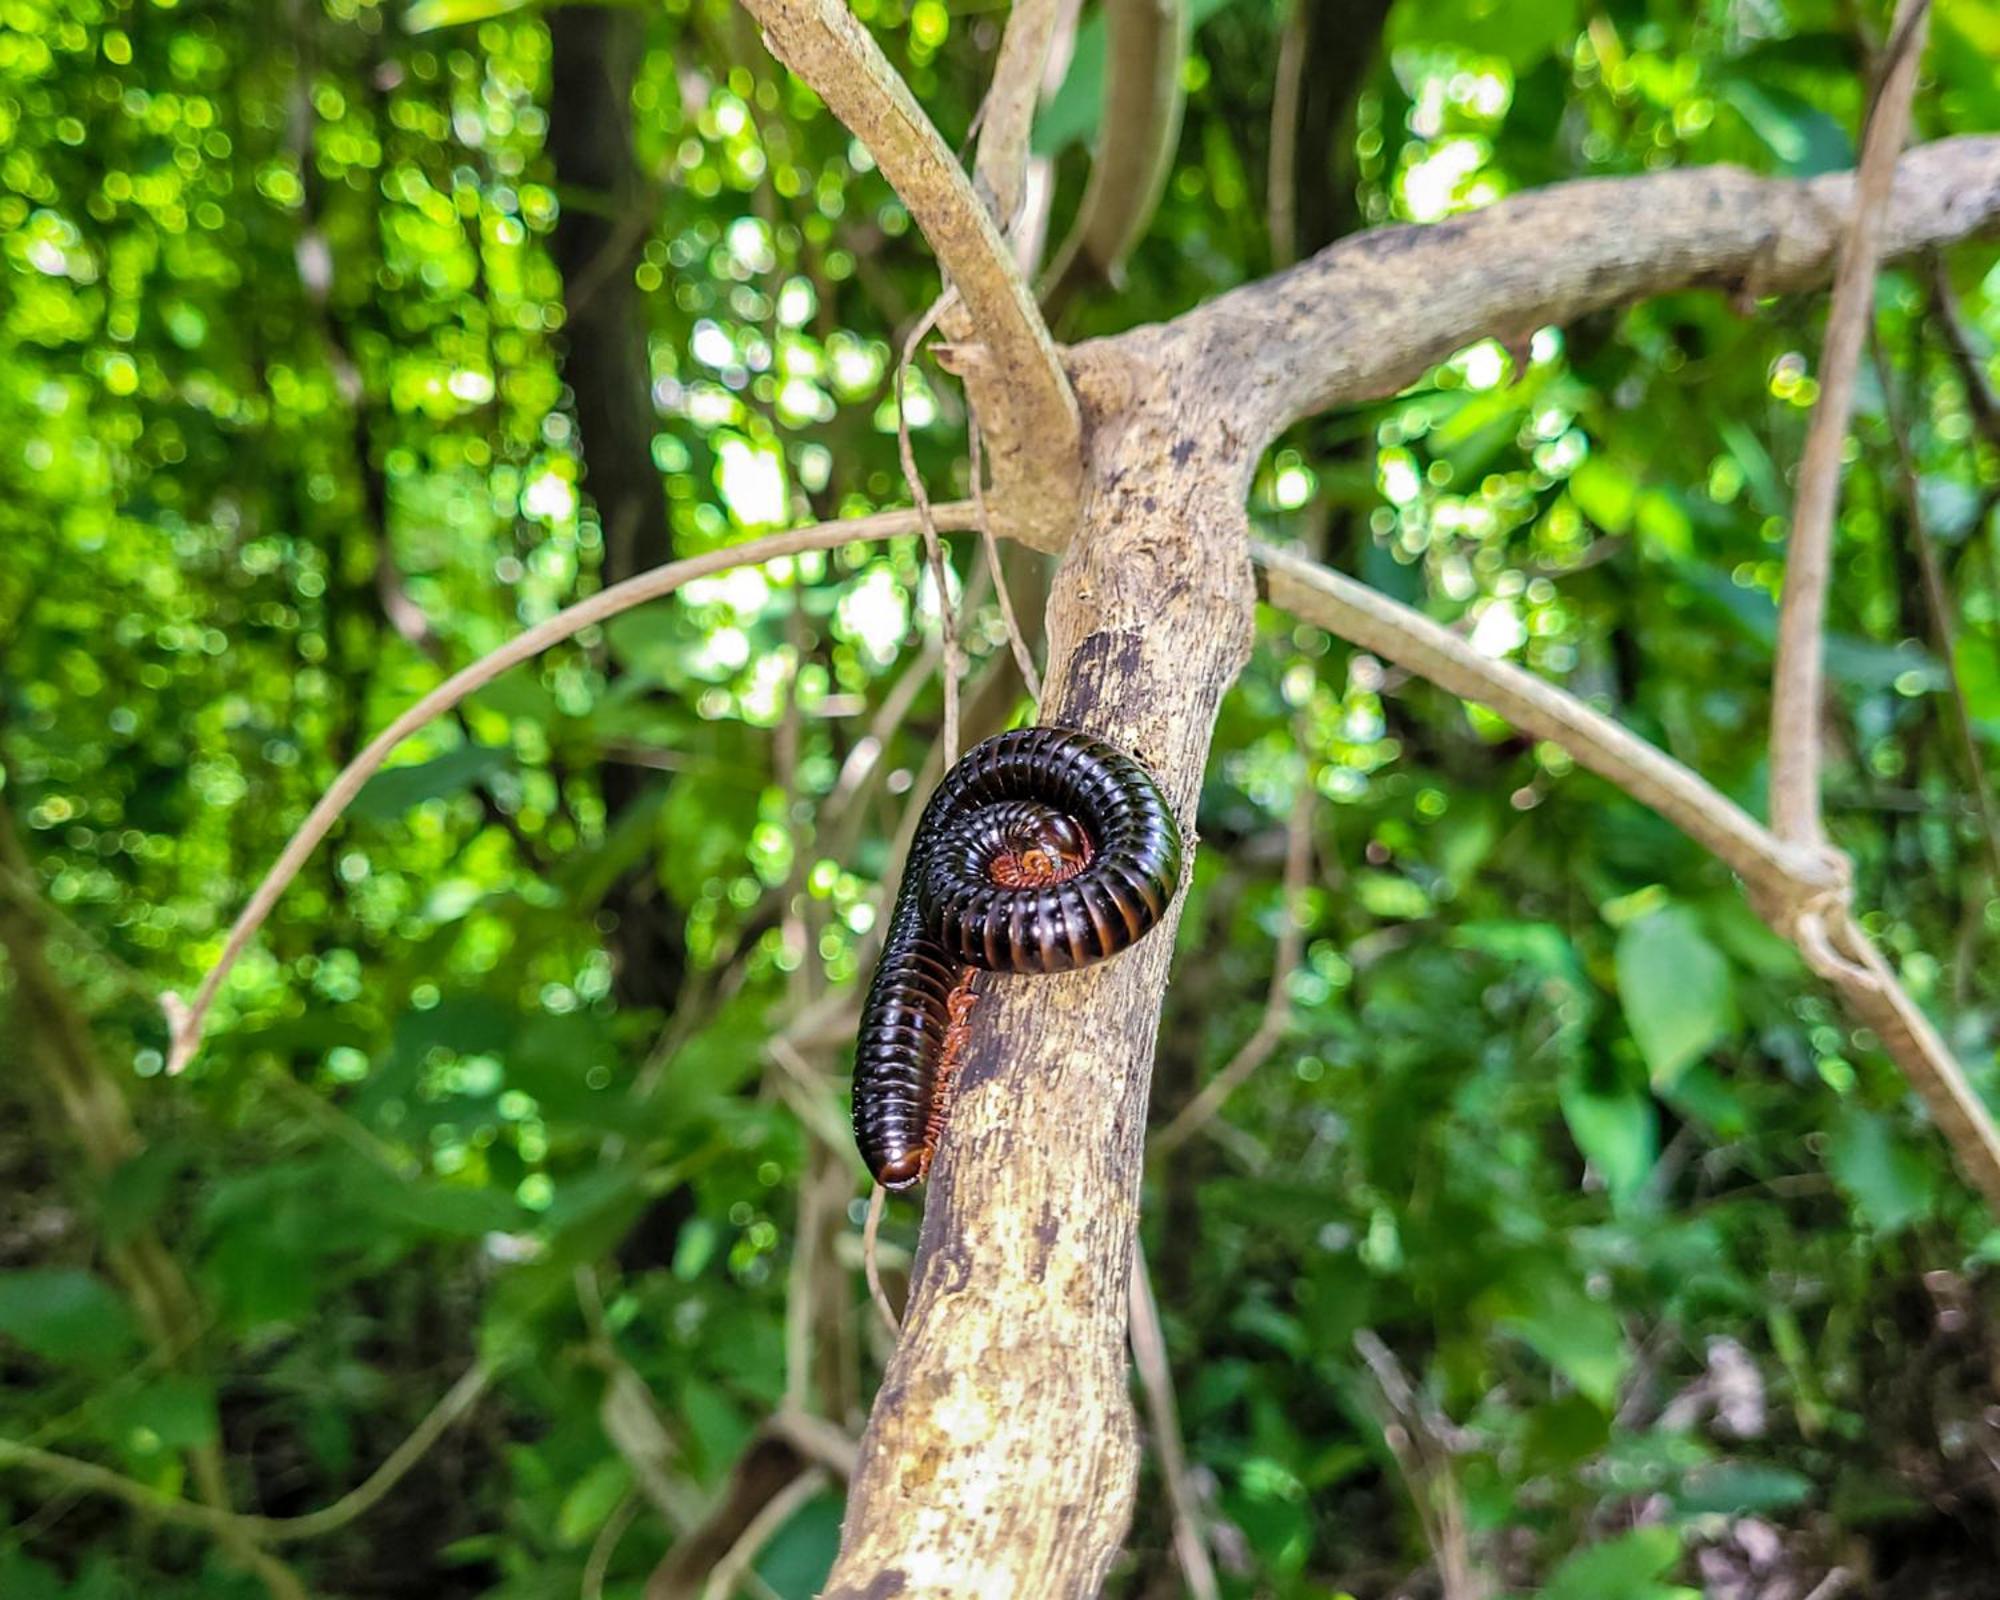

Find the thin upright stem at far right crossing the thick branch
[[1770, 0, 1930, 844]]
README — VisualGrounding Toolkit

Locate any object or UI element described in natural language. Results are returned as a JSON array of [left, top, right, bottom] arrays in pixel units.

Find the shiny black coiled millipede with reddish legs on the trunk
[[854, 728, 1180, 1188]]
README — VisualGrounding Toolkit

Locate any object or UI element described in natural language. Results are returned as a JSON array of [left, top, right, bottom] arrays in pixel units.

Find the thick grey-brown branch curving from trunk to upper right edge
[[1160, 136, 2000, 440]]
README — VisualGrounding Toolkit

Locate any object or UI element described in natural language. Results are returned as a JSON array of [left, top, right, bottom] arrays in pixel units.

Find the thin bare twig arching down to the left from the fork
[[162, 502, 976, 1072]]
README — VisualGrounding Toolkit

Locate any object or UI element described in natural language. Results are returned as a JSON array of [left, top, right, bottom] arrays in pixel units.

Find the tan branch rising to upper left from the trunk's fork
[[744, 0, 1082, 550]]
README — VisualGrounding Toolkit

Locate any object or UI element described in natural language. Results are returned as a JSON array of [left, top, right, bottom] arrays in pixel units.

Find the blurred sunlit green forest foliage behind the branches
[[0, 0, 2000, 1600]]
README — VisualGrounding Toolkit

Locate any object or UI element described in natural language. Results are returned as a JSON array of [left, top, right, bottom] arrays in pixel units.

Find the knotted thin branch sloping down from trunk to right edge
[[1256, 546, 2000, 1214]]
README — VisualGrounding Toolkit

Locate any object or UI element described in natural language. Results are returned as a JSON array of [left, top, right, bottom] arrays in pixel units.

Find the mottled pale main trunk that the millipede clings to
[[828, 342, 1258, 1600]]
